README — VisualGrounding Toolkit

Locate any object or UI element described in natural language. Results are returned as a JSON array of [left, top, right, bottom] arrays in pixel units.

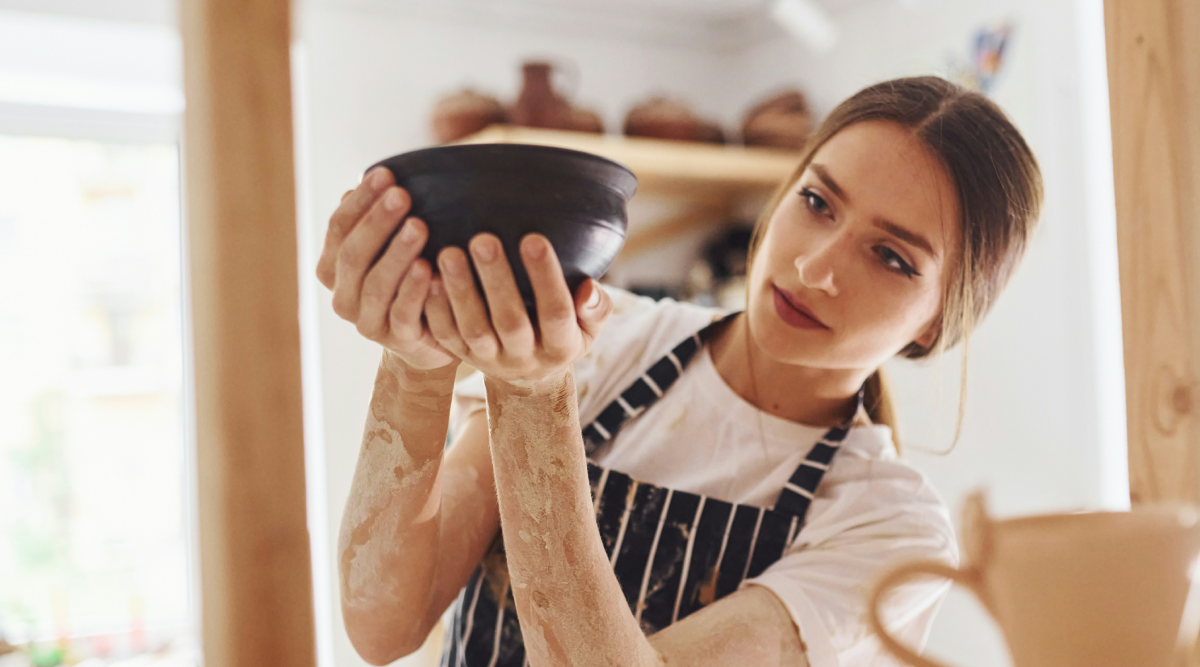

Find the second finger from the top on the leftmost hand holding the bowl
[[334, 187, 410, 322]]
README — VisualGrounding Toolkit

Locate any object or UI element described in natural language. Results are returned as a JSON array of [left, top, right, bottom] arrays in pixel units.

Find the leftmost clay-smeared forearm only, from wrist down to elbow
[[338, 350, 455, 651]]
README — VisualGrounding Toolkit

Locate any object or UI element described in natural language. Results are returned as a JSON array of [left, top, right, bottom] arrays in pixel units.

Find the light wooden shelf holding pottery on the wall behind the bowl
[[457, 125, 799, 203]]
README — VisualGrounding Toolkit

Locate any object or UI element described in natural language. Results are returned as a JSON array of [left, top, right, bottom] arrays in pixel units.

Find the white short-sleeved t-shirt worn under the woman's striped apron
[[455, 288, 959, 667]]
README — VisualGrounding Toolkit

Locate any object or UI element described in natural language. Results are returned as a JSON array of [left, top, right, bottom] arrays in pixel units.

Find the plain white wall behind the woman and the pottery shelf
[[298, 0, 1127, 667]]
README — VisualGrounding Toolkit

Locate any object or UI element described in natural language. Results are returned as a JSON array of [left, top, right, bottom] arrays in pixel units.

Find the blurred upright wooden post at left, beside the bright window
[[180, 0, 316, 667]]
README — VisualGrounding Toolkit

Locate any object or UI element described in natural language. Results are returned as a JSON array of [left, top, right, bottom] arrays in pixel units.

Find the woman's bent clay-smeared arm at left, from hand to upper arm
[[317, 168, 499, 665]]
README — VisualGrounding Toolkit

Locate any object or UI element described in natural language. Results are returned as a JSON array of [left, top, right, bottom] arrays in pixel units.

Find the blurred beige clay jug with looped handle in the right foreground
[[870, 493, 1200, 667]]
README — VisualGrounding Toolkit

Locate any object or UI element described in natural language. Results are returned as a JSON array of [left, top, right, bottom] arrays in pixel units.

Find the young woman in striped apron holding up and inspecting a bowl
[[318, 78, 1042, 667]]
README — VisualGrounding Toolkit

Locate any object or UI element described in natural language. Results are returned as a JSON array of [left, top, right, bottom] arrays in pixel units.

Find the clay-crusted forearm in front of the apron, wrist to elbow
[[487, 371, 661, 667]]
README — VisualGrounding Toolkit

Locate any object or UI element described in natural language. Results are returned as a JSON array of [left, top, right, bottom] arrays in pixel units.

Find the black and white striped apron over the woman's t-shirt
[[440, 316, 862, 667]]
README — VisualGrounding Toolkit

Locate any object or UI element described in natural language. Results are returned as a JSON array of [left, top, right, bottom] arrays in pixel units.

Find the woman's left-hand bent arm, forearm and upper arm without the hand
[[337, 351, 499, 665]]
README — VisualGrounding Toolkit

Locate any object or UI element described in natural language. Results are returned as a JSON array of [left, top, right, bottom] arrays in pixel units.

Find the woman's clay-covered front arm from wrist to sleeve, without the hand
[[487, 372, 808, 667]]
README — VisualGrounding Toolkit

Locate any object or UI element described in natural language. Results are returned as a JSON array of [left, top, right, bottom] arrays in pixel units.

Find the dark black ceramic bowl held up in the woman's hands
[[372, 144, 637, 313]]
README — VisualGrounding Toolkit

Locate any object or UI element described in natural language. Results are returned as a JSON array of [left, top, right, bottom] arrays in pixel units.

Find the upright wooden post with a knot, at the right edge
[[1104, 0, 1200, 503]]
